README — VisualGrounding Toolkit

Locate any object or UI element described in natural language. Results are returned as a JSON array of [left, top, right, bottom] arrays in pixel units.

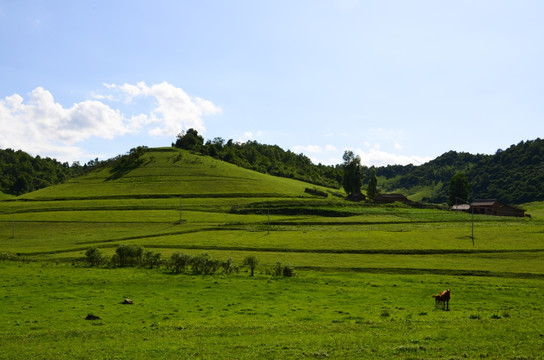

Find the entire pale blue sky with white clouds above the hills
[[0, 0, 544, 166]]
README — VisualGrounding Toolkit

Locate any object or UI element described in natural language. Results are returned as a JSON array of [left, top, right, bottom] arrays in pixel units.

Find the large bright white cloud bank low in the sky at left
[[0, 82, 221, 161]]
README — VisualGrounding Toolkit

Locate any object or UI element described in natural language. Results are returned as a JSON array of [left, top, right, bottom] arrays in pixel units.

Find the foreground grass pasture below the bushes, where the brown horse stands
[[0, 262, 544, 359]]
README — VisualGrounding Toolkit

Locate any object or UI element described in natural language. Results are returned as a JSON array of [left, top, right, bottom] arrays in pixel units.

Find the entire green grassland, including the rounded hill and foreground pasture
[[0, 149, 544, 359]]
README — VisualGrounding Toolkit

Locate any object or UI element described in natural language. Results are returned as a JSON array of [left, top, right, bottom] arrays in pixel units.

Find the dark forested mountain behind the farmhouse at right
[[376, 138, 544, 204]]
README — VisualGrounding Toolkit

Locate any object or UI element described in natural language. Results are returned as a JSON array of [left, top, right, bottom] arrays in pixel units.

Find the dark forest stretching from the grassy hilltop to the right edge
[[176, 129, 544, 204]]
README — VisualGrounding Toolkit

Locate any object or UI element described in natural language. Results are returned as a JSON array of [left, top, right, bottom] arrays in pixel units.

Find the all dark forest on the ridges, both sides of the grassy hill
[[0, 134, 544, 204]]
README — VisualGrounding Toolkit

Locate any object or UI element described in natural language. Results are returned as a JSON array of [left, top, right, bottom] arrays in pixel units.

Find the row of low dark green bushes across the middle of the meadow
[[84, 245, 295, 277]]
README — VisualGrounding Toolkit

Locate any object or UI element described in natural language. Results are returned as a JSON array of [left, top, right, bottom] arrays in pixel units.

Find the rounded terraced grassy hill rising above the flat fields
[[21, 148, 330, 200]]
